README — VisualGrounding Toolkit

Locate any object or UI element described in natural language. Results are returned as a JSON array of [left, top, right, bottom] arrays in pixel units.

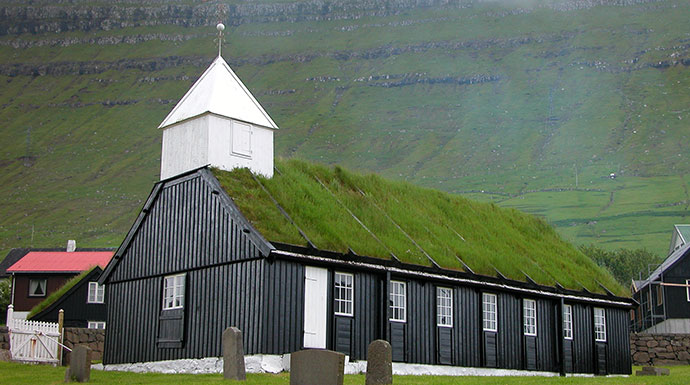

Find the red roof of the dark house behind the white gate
[[7, 251, 113, 273]]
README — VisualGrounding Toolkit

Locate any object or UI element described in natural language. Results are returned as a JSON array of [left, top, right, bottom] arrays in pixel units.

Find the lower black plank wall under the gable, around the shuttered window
[[103, 260, 265, 364]]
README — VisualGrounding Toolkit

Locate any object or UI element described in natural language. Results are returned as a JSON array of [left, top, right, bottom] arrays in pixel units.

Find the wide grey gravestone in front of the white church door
[[290, 349, 345, 385]]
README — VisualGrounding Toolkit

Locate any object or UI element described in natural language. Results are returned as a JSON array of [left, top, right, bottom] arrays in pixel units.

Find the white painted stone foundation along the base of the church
[[91, 354, 608, 377]]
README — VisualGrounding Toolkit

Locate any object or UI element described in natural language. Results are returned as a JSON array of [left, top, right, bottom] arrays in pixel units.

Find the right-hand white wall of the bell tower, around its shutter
[[206, 114, 273, 178]]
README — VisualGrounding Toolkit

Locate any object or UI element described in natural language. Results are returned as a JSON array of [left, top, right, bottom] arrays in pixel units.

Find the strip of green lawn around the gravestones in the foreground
[[0, 362, 690, 385]]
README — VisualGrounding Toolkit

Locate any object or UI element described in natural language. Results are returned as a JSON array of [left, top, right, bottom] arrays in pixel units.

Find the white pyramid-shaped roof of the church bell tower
[[158, 56, 278, 129]]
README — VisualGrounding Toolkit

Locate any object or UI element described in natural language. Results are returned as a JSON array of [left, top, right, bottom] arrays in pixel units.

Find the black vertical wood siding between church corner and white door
[[261, 260, 304, 354]]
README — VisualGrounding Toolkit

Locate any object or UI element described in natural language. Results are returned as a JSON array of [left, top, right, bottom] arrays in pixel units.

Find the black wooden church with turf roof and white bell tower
[[100, 51, 633, 374]]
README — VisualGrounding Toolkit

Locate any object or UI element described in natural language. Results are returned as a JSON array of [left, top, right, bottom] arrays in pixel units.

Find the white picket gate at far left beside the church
[[7, 305, 63, 364]]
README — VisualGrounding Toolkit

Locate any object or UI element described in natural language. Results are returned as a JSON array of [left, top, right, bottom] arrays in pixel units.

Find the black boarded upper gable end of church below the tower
[[104, 169, 272, 282]]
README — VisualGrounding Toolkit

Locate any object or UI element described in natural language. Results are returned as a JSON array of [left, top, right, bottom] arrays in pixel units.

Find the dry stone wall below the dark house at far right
[[630, 333, 690, 366]]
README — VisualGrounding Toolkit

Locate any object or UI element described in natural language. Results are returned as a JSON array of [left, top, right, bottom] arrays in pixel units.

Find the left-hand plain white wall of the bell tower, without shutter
[[161, 115, 209, 179]]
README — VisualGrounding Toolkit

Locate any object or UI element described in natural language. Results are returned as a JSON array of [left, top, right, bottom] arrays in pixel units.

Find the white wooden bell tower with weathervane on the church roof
[[158, 24, 278, 179]]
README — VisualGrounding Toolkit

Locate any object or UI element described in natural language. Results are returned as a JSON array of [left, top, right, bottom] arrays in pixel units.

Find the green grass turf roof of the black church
[[213, 160, 627, 296]]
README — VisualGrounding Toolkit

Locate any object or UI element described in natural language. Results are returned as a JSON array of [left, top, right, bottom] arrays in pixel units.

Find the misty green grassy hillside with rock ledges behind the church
[[0, 0, 690, 260]]
